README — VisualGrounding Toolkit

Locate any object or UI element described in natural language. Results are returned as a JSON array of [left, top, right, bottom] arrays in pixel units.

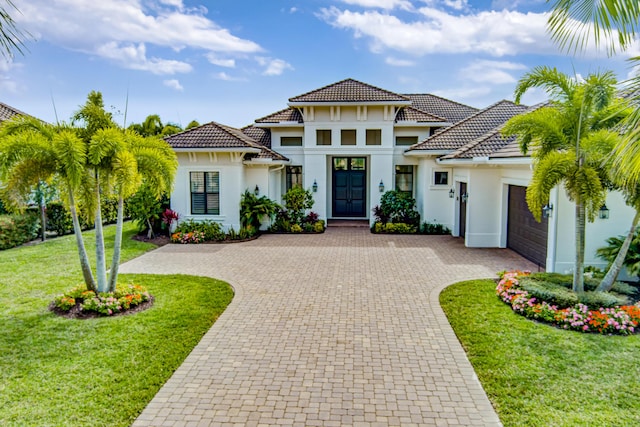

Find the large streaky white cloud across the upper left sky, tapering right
[[15, 0, 262, 72]]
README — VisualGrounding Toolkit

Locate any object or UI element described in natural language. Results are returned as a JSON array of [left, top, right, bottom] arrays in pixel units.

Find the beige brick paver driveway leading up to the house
[[121, 228, 535, 426]]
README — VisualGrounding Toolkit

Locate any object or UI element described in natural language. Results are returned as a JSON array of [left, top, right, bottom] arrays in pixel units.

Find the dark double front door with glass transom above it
[[332, 157, 367, 218]]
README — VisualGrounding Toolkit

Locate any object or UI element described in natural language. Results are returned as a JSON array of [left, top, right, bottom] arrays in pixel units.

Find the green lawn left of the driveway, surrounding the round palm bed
[[0, 224, 233, 426]]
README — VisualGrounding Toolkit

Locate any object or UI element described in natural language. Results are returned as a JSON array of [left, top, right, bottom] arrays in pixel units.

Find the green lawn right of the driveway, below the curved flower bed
[[440, 280, 640, 427]]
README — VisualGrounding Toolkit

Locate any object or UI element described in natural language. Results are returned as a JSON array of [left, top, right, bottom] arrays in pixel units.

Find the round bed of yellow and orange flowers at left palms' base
[[50, 284, 153, 317]]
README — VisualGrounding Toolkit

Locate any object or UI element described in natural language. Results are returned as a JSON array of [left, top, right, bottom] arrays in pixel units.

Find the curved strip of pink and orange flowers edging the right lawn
[[496, 271, 640, 335]]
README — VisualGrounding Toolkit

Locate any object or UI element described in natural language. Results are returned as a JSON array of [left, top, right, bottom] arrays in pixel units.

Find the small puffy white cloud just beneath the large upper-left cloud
[[95, 42, 192, 74]]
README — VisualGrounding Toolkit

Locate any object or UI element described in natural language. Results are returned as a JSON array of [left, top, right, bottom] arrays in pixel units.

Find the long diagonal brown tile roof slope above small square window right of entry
[[407, 100, 528, 151]]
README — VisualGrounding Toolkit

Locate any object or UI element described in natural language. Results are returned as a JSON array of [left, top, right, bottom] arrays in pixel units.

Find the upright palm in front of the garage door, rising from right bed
[[503, 67, 621, 292]]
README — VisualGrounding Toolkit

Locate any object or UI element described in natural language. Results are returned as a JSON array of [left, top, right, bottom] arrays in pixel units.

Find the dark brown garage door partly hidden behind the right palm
[[507, 185, 548, 267]]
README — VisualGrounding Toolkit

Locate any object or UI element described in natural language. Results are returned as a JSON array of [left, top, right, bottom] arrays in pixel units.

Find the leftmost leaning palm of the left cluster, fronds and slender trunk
[[0, 117, 97, 290]]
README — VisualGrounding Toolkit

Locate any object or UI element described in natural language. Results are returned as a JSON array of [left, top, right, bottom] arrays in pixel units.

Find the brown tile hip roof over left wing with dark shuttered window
[[164, 122, 287, 161]]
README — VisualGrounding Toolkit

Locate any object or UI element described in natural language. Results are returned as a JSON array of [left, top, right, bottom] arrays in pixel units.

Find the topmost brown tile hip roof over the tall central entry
[[289, 79, 410, 103]]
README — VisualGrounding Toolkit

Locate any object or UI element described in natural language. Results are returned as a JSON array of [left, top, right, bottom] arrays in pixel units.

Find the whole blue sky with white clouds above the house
[[0, 0, 640, 127]]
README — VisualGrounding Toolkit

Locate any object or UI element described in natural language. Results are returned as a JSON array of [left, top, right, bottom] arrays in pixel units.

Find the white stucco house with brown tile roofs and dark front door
[[166, 79, 633, 272]]
